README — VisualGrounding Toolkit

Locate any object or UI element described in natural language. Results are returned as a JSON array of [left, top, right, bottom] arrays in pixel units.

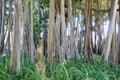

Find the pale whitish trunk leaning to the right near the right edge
[[102, 0, 118, 63]]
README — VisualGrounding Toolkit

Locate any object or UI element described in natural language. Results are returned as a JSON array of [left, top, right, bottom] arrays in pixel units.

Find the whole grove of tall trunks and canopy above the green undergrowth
[[0, 0, 120, 80]]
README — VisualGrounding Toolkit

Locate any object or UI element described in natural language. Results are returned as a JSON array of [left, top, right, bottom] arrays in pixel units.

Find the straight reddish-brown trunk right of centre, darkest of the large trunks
[[84, 0, 92, 62]]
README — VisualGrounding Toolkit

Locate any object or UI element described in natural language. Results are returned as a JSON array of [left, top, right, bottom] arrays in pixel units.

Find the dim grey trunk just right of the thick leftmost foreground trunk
[[23, 1, 30, 60]]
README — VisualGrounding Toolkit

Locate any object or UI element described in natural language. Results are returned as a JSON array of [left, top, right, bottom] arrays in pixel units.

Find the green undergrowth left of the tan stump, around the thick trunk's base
[[0, 55, 42, 80]]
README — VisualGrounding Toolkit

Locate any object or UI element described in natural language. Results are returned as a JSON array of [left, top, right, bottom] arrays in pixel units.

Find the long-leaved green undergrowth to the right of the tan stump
[[46, 56, 120, 80]]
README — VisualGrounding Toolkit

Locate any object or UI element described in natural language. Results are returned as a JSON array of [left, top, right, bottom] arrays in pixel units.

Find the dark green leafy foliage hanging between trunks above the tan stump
[[33, 0, 49, 41]]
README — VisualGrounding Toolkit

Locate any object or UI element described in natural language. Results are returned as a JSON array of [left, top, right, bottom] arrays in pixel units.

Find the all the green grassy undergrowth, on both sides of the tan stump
[[0, 56, 120, 80]]
